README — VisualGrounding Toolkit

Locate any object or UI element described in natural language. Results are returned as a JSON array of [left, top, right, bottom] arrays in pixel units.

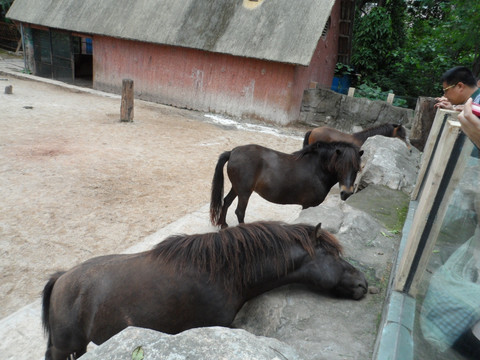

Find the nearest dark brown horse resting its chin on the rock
[[42, 222, 368, 360]]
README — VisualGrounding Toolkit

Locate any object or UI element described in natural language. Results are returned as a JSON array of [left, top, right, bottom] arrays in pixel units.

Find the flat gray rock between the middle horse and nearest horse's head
[[295, 185, 409, 284]]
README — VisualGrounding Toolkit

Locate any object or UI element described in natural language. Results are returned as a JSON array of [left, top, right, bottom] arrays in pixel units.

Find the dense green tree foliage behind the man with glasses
[[352, 0, 480, 97]]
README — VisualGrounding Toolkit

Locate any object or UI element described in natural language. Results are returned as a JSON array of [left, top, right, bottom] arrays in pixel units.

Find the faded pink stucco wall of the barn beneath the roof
[[93, 2, 339, 124]]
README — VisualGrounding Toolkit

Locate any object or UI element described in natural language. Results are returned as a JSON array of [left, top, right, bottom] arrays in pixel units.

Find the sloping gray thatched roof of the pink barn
[[7, 0, 335, 65]]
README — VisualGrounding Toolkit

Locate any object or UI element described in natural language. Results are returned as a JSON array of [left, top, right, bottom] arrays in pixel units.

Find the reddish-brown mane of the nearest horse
[[151, 222, 342, 290]]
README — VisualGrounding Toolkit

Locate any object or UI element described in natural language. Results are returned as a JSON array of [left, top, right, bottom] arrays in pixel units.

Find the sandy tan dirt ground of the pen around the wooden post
[[0, 74, 305, 318]]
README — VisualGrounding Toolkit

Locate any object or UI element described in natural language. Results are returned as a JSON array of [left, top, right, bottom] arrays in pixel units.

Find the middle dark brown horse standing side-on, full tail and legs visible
[[210, 142, 363, 228]]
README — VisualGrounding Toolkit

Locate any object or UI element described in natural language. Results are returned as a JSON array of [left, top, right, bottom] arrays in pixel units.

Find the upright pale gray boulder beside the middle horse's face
[[357, 135, 421, 194]]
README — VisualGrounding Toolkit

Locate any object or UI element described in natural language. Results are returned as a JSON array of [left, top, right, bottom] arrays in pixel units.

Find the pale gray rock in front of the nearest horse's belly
[[80, 327, 301, 360]]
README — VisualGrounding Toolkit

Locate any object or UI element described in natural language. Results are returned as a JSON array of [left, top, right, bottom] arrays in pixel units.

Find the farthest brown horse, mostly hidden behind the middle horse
[[303, 124, 410, 148]]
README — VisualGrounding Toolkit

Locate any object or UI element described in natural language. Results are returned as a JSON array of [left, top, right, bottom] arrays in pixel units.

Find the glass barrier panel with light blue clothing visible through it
[[413, 139, 480, 360]]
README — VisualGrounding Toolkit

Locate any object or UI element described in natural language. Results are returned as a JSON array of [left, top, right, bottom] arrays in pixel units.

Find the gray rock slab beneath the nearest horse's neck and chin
[[233, 285, 382, 360]]
